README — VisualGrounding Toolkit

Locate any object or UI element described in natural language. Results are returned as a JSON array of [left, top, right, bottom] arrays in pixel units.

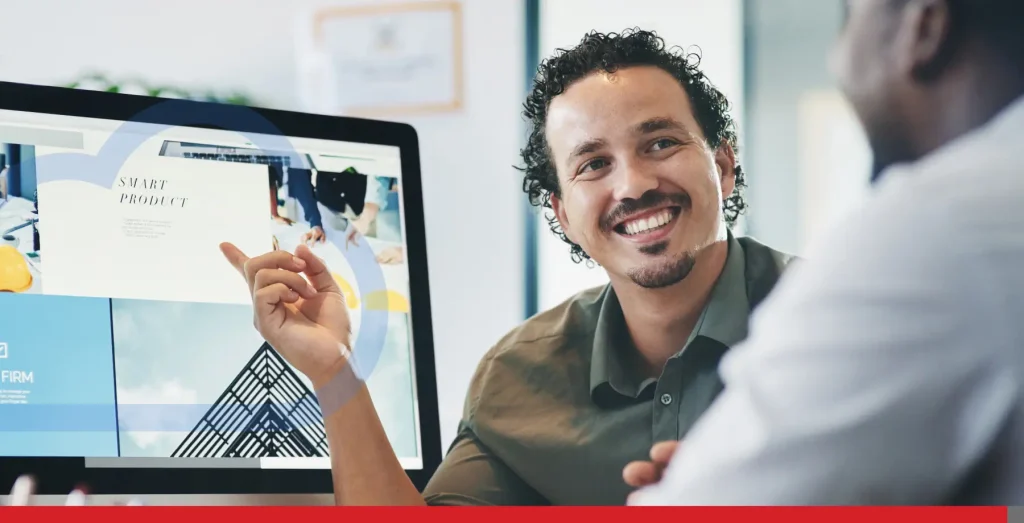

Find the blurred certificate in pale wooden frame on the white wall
[[297, 1, 464, 117]]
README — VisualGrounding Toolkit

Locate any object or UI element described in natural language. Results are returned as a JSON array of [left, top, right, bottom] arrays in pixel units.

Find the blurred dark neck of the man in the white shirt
[[914, 53, 1024, 158]]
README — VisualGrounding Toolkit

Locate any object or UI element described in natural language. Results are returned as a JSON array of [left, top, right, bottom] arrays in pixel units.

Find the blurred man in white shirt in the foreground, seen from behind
[[629, 0, 1024, 507]]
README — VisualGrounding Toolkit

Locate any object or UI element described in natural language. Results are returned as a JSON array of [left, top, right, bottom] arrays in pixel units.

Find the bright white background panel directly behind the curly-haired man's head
[[538, 0, 743, 310]]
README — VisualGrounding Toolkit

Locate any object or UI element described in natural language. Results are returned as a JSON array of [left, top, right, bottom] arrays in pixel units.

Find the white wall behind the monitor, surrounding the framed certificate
[[0, 0, 525, 483]]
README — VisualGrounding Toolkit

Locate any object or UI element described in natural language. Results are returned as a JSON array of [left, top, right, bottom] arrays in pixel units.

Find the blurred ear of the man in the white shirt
[[895, 0, 953, 80]]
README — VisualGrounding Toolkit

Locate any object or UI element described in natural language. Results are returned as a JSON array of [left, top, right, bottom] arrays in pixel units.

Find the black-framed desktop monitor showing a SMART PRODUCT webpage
[[0, 83, 441, 498]]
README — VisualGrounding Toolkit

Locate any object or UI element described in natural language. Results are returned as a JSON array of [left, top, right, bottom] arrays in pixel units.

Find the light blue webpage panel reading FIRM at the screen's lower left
[[0, 293, 118, 456]]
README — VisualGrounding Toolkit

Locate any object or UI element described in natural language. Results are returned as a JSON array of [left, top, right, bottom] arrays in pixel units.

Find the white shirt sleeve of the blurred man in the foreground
[[630, 169, 1024, 506]]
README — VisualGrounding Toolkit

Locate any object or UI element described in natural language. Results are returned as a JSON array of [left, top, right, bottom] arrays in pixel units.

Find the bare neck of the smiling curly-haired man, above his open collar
[[611, 235, 729, 377]]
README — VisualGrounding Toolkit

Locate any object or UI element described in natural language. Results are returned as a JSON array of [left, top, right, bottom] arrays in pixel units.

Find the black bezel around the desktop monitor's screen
[[0, 82, 441, 495]]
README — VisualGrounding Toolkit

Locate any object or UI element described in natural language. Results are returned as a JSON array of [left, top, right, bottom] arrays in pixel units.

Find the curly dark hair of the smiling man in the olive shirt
[[517, 29, 746, 263]]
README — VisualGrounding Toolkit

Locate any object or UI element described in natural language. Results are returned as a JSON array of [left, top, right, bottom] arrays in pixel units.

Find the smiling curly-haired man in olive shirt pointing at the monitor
[[216, 31, 791, 505]]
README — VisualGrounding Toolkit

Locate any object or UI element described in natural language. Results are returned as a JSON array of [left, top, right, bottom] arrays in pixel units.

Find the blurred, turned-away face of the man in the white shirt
[[829, 0, 914, 177]]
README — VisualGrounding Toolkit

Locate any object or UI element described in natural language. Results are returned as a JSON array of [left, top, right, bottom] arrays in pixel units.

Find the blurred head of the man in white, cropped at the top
[[833, 0, 1024, 175]]
